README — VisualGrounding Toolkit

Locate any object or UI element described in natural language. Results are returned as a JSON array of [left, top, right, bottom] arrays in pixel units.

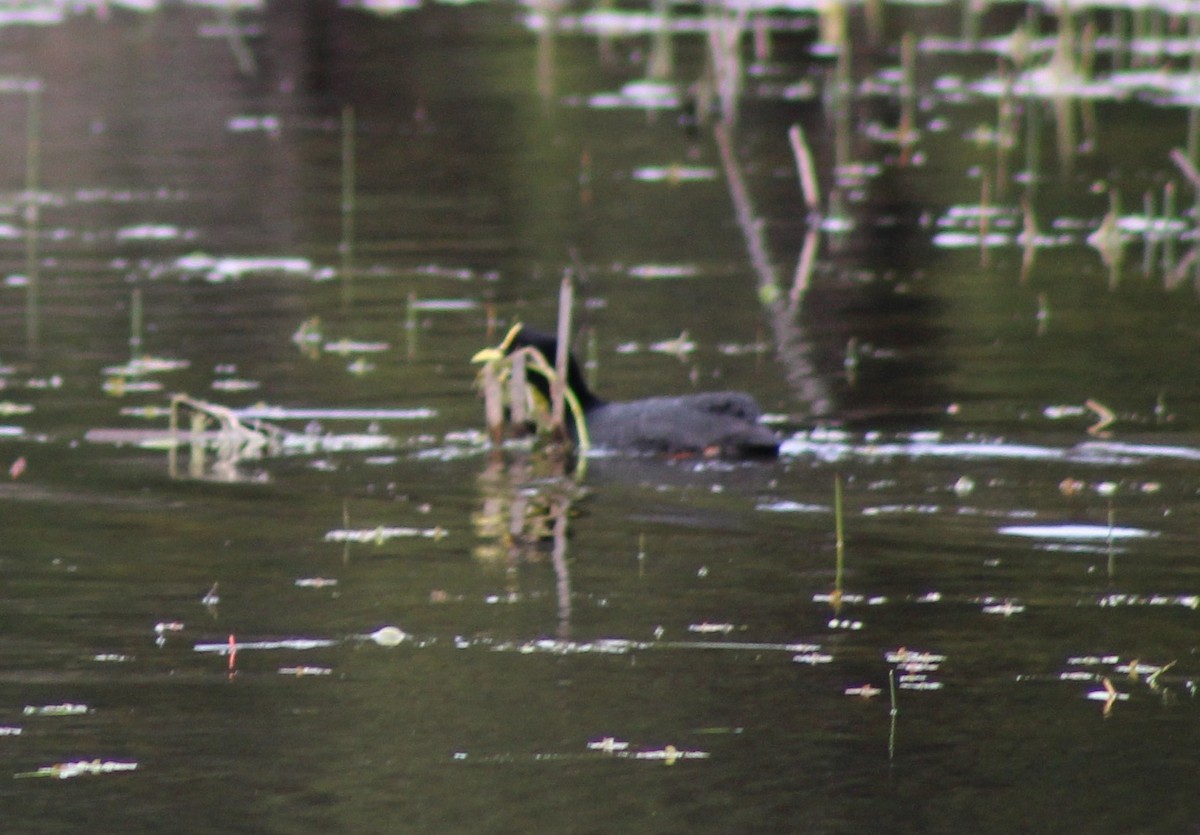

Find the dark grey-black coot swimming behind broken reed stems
[[477, 325, 779, 458]]
